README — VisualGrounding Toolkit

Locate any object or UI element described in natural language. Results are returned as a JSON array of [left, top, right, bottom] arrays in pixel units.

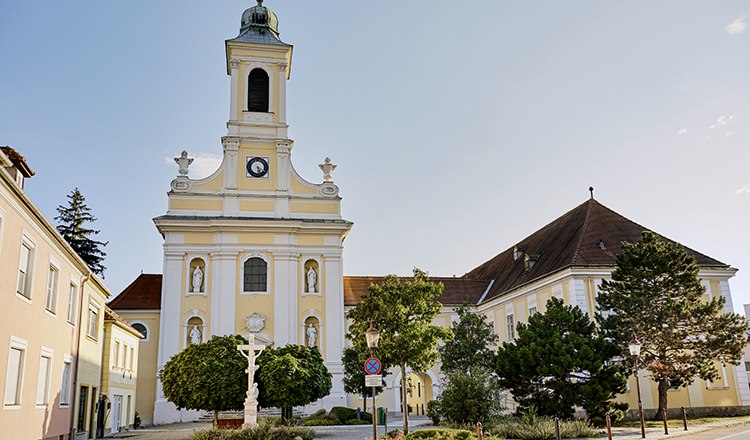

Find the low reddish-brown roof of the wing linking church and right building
[[344, 276, 490, 306]]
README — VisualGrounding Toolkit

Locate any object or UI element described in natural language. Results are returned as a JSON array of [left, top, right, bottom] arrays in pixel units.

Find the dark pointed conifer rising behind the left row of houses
[[55, 188, 109, 276]]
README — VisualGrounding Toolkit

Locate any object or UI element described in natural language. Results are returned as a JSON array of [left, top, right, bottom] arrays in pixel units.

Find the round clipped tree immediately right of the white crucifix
[[255, 344, 332, 419]]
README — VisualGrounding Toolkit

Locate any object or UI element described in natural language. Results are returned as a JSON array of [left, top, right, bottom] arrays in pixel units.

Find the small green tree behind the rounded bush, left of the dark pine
[[438, 305, 498, 376]]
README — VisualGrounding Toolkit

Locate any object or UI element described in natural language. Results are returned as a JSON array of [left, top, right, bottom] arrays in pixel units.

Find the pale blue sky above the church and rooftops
[[0, 0, 750, 311]]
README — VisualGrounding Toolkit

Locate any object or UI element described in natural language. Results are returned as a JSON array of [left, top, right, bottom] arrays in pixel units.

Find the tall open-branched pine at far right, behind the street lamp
[[597, 231, 748, 414]]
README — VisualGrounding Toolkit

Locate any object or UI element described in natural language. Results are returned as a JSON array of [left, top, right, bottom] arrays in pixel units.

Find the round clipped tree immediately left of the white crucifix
[[159, 336, 247, 427]]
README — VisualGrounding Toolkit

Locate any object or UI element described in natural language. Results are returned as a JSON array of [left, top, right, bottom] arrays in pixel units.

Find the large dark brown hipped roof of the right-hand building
[[464, 198, 729, 299]]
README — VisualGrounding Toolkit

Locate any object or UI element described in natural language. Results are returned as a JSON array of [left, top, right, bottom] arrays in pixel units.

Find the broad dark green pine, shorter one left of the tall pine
[[496, 298, 626, 419]]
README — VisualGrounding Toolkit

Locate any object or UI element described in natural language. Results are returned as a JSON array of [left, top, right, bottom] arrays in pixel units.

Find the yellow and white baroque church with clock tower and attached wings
[[109, 0, 750, 424]]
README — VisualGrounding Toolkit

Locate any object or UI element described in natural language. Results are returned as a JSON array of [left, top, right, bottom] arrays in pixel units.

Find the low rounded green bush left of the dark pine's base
[[440, 370, 500, 425]]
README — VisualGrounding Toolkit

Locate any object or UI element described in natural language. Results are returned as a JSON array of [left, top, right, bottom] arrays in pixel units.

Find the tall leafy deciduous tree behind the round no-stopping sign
[[346, 269, 451, 432]]
